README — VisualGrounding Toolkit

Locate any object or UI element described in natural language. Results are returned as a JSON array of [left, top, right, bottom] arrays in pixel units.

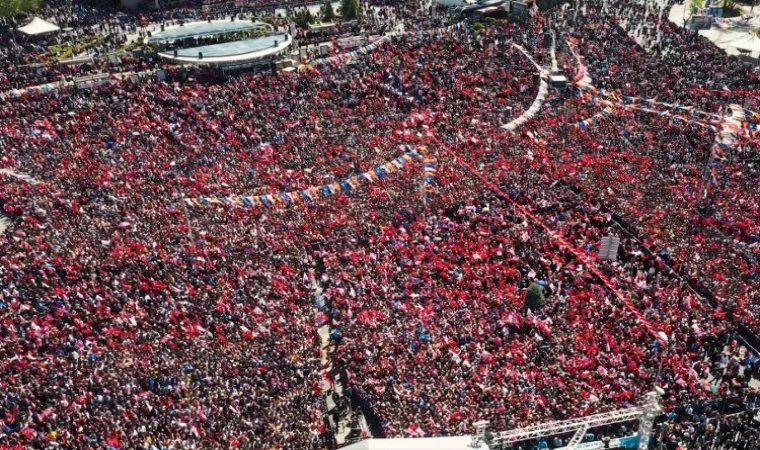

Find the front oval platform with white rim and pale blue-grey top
[[159, 34, 293, 66]]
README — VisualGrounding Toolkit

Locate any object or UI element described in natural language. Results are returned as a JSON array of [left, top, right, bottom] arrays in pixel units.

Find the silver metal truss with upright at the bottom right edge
[[478, 390, 662, 450]]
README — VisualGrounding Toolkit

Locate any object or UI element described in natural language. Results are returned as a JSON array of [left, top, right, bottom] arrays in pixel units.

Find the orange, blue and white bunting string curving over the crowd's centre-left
[[184, 146, 438, 208]]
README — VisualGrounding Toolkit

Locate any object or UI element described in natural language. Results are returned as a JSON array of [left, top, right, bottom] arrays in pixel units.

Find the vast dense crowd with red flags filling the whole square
[[0, 0, 760, 449]]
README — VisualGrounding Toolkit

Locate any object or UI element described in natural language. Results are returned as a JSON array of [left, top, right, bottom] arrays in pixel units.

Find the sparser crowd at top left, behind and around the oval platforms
[[0, 2, 420, 91]]
